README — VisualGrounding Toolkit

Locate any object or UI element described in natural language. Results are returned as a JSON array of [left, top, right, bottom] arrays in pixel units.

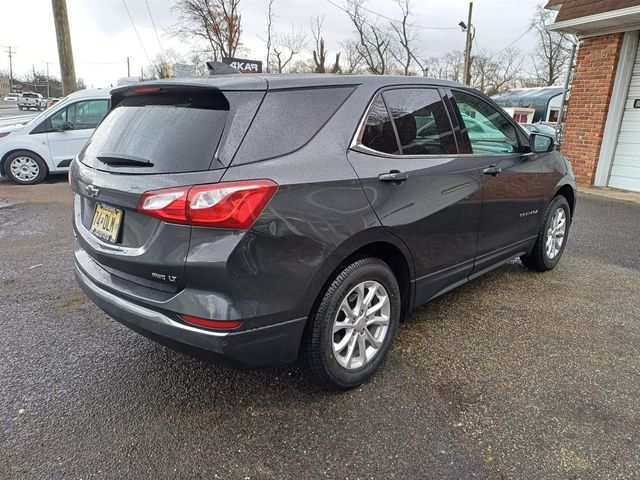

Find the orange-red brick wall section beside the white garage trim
[[562, 33, 624, 185]]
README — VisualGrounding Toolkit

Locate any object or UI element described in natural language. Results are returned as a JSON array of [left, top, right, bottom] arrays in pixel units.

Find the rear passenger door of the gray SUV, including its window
[[348, 87, 482, 303]]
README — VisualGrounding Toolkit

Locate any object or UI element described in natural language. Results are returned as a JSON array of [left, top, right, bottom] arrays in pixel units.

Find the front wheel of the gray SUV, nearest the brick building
[[520, 195, 571, 272]]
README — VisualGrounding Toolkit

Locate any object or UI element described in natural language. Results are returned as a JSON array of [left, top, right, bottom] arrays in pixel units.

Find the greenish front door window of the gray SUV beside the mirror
[[453, 91, 519, 155]]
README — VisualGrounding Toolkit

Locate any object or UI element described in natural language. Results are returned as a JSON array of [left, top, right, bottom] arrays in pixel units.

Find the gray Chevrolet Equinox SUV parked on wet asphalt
[[70, 75, 576, 388]]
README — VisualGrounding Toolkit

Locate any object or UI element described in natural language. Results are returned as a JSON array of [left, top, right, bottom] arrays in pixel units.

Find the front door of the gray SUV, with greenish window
[[452, 90, 545, 274]]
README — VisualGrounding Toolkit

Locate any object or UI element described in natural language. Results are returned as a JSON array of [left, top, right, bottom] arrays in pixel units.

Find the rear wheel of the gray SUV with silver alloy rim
[[304, 258, 401, 390]]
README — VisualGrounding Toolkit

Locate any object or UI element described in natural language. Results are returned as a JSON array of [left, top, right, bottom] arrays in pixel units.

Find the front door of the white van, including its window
[[46, 98, 109, 167]]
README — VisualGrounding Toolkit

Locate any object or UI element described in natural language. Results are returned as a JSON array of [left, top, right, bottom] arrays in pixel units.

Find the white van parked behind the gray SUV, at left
[[0, 89, 111, 185]]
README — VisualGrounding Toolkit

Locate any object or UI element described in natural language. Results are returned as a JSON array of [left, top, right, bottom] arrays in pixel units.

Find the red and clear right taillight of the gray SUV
[[138, 180, 278, 230]]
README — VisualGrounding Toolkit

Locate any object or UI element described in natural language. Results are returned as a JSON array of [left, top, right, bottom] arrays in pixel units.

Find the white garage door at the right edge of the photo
[[609, 39, 640, 192]]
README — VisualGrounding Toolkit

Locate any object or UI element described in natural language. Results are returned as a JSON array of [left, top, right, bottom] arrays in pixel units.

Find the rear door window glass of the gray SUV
[[383, 88, 457, 155]]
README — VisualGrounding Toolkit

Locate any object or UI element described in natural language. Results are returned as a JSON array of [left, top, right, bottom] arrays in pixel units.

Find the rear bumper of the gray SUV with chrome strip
[[75, 264, 306, 368]]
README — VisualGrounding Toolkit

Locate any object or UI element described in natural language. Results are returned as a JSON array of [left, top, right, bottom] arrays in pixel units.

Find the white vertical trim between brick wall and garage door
[[593, 30, 640, 187]]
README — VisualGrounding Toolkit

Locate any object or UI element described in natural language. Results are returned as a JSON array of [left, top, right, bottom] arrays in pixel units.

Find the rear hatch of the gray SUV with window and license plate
[[70, 80, 266, 293]]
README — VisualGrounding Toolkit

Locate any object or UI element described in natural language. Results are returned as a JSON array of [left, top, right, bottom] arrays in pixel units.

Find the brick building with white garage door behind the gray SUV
[[547, 0, 640, 191]]
